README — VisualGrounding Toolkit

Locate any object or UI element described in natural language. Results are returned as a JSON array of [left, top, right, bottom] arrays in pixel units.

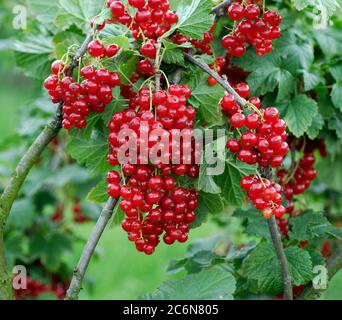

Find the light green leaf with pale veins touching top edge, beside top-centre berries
[[168, 0, 214, 39]]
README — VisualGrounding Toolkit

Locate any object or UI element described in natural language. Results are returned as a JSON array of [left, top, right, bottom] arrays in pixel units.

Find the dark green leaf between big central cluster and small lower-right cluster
[[215, 158, 255, 206]]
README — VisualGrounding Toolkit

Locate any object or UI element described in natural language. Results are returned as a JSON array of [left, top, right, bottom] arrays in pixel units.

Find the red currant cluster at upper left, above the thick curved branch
[[44, 60, 120, 130]]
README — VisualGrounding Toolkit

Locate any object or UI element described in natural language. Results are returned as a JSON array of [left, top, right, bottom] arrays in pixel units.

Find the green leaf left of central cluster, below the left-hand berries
[[67, 134, 110, 174]]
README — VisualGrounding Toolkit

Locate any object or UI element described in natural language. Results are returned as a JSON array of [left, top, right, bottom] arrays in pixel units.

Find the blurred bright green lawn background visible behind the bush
[[0, 1, 342, 299]]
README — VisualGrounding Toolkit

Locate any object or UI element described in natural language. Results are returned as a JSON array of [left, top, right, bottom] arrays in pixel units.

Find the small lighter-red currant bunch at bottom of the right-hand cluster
[[240, 175, 286, 219]]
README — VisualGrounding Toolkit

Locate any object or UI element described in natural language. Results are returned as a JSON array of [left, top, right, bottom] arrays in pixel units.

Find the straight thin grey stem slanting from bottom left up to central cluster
[[65, 198, 118, 300]]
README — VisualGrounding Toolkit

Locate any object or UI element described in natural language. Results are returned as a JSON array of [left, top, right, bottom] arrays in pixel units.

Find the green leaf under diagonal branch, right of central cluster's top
[[188, 72, 225, 125]]
